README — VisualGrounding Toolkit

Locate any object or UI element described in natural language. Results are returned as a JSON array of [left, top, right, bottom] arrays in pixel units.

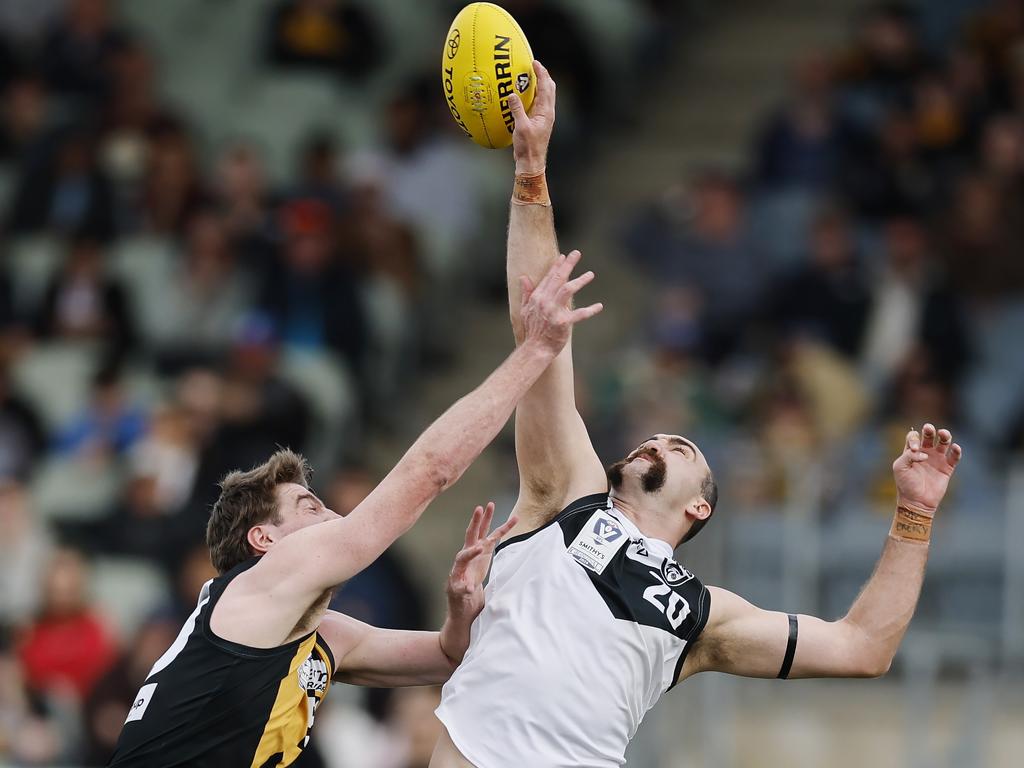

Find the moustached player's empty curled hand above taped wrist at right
[[893, 424, 964, 516]]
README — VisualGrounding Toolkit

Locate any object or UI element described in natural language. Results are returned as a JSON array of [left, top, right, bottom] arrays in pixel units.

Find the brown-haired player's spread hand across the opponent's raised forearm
[[519, 251, 604, 354]]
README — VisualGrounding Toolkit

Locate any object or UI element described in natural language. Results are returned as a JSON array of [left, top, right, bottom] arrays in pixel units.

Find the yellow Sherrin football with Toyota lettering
[[441, 3, 537, 150]]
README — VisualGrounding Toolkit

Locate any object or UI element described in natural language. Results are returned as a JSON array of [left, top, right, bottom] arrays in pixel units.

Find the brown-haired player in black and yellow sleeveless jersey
[[111, 253, 601, 768]]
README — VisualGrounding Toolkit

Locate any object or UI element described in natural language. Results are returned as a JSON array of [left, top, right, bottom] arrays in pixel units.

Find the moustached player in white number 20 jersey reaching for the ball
[[431, 63, 961, 768]]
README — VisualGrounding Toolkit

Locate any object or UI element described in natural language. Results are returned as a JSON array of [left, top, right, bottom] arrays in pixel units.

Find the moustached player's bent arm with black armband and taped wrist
[[680, 424, 962, 679]]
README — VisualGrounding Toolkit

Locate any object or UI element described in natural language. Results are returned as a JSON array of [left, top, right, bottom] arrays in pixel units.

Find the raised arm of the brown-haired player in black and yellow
[[232, 259, 601, 645]]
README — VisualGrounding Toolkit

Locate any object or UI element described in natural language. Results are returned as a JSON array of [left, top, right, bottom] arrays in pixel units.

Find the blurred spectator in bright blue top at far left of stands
[[54, 362, 146, 461]]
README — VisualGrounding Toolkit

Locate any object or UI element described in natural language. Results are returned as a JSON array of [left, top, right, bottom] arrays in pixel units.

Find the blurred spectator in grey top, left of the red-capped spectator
[[146, 208, 254, 368]]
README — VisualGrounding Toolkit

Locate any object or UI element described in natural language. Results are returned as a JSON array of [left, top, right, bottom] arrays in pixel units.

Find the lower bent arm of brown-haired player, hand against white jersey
[[318, 503, 516, 687]]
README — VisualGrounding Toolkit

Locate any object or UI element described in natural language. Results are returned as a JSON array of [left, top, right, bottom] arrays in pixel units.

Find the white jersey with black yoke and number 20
[[437, 494, 711, 768]]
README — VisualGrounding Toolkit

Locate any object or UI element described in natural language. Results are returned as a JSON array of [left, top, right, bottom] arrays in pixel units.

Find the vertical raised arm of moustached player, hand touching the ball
[[507, 61, 607, 529]]
